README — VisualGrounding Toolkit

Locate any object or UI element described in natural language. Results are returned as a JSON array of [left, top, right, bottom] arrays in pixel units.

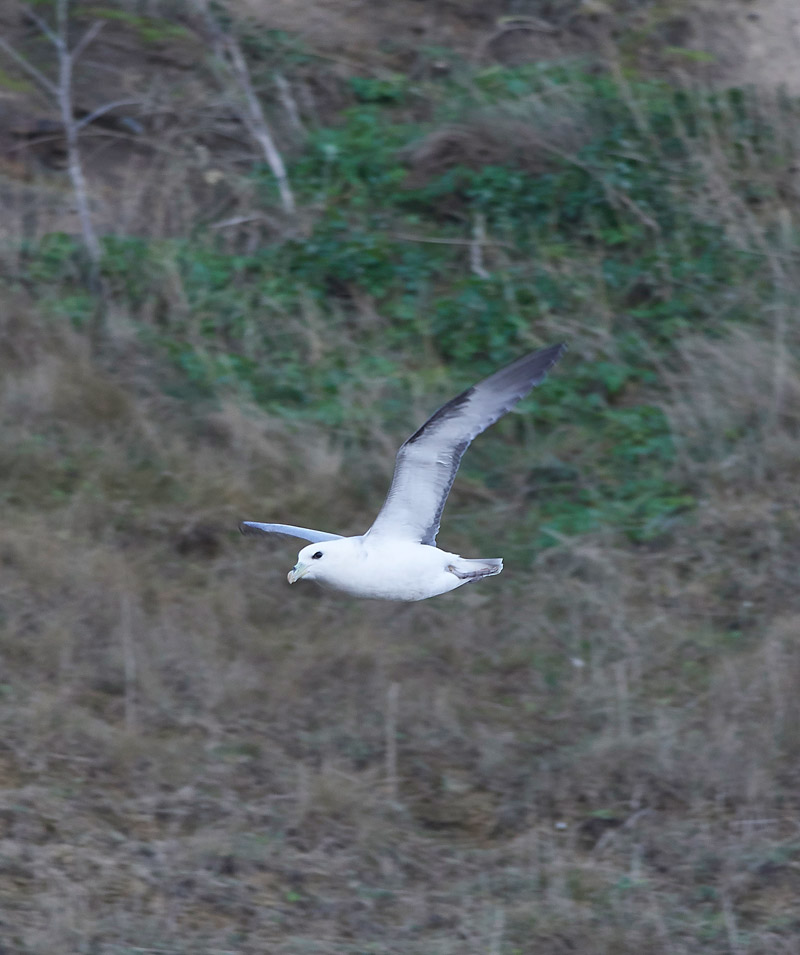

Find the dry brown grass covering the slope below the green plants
[[0, 300, 800, 955]]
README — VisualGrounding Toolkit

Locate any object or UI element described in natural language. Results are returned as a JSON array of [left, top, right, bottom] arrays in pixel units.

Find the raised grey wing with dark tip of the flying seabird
[[368, 344, 567, 545]]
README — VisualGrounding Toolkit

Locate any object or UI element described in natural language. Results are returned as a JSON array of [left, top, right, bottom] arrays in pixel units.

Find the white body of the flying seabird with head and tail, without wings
[[289, 534, 496, 600]]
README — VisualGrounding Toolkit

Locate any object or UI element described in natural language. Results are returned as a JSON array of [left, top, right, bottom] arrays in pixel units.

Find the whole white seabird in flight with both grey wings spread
[[239, 344, 567, 600]]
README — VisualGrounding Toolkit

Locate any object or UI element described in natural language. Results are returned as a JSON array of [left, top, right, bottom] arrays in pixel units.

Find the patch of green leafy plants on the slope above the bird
[[18, 66, 788, 556]]
